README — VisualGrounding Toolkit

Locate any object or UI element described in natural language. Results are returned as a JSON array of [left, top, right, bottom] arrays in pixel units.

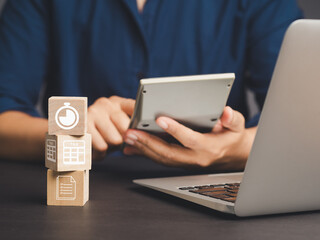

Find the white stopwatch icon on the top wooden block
[[55, 102, 79, 130]]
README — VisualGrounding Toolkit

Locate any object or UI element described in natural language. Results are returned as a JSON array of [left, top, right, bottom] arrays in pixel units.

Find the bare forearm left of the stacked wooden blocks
[[0, 111, 48, 161]]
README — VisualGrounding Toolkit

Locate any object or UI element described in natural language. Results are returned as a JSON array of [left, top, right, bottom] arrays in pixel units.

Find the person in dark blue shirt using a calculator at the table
[[0, 0, 301, 169]]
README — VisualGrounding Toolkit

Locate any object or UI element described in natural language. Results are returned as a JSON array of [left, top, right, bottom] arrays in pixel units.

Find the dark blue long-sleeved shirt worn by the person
[[0, 0, 301, 126]]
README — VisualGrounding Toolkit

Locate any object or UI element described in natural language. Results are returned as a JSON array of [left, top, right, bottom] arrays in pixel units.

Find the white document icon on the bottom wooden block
[[56, 176, 76, 200]]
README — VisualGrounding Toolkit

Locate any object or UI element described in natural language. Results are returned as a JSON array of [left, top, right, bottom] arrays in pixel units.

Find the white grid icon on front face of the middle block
[[63, 140, 85, 165]]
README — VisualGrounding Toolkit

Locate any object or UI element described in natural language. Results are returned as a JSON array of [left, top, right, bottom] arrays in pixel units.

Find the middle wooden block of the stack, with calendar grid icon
[[45, 133, 91, 172]]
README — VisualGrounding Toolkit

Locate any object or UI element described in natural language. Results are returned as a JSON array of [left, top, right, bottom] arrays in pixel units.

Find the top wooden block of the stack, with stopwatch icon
[[48, 97, 88, 135]]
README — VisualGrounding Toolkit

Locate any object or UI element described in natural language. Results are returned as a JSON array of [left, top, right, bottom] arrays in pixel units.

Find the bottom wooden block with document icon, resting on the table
[[47, 169, 89, 206]]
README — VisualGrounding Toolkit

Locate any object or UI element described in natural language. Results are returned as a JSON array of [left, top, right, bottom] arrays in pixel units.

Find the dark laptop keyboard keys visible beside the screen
[[179, 183, 240, 203]]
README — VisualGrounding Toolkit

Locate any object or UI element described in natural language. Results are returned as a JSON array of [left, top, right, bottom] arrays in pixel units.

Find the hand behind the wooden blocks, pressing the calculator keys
[[88, 96, 135, 159]]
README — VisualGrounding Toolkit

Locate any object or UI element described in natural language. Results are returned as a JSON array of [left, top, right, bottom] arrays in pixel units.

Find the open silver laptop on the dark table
[[134, 20, 320, 216]]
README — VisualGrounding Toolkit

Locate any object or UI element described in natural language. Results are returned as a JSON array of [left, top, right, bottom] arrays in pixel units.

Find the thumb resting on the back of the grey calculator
[[156, 117, 202, 149]]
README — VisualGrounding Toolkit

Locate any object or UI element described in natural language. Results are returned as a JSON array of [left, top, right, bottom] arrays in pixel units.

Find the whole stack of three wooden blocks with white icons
[[45, 97, 91, 206]]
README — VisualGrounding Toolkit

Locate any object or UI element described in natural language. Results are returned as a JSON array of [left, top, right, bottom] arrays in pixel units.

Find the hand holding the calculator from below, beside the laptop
[[124, 107, 256, 170]]
